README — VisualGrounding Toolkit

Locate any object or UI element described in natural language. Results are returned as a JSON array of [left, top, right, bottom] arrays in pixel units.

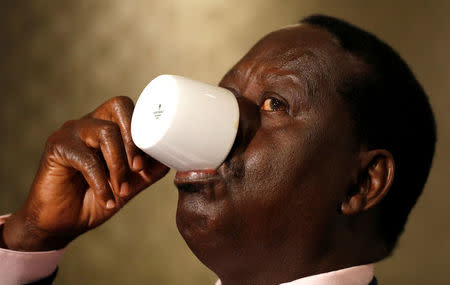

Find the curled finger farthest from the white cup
[[57, 139, 116, 210]]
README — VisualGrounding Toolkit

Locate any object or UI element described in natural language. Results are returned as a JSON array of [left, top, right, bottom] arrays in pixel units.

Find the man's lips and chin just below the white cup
[[174, 171, 250, 273]]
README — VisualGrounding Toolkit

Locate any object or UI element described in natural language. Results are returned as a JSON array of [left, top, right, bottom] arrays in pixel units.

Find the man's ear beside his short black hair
[[341, 149, 395, 215]]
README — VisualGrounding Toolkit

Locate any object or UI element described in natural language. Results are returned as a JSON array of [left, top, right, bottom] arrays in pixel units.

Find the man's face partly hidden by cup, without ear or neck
[[176, 25, 358, 272]]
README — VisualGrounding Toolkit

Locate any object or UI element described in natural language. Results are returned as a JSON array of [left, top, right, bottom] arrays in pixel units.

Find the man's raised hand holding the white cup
[[3, 97, 169, 251]]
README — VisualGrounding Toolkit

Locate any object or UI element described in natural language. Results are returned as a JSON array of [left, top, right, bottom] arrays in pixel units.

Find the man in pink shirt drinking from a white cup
[[0, 15, 436, 285]]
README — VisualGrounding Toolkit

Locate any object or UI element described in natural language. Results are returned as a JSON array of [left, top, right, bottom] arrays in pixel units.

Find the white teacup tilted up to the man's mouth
[[131, 75, 239, 171]]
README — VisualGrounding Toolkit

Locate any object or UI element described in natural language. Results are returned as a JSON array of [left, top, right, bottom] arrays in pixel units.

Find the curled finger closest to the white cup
[[92, 96, 144, 171]]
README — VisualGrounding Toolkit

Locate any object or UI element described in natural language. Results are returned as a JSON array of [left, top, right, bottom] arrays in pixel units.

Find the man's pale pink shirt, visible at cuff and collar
[[0, 215, 374, 285]]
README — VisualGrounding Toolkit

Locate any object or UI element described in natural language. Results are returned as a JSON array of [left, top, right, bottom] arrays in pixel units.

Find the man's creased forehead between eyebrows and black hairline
[[224, 24, 350, 102]]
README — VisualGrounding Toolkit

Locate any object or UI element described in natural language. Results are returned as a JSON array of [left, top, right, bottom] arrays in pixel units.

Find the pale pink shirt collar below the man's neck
[[216, 264, 374, 285]]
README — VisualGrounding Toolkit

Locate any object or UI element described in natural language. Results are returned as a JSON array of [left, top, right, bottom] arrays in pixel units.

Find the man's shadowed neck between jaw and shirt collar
[[214, 213, 388, 285]]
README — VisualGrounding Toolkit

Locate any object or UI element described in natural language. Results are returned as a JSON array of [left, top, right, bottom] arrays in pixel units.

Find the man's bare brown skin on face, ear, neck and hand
[[3, 25, 394, 285]]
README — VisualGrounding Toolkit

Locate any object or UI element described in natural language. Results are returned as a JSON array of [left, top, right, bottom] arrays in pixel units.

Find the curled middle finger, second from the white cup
[[78, 119, 129, 197]]
